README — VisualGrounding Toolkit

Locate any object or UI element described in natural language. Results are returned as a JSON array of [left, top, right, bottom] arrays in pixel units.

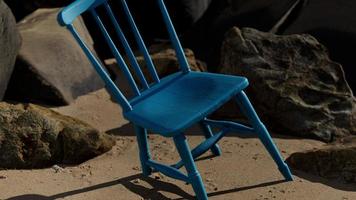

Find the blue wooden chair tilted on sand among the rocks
[[58, 0, 293, 199]]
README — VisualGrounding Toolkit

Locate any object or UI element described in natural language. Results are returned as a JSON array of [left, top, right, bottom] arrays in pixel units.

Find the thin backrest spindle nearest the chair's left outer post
[[90, 9, 141, 96]]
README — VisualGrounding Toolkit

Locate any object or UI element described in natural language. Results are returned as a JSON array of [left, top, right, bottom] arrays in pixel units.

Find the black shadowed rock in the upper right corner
[[281, 0, 356, 93]]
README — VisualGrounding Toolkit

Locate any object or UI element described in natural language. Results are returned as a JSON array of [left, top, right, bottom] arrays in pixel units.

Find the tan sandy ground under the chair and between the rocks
[[0, 90, 356, 200]]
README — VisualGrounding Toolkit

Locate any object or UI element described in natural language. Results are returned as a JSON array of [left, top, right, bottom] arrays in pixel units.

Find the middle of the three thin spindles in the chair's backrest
[[104, 2, 149, 89]]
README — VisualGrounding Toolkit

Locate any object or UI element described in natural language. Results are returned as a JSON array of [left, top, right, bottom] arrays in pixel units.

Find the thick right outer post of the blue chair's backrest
[[157, 0, 190, 72]]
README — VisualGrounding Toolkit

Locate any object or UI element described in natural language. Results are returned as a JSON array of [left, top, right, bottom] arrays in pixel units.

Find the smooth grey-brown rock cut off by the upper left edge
[[0, 0, 21, 100]]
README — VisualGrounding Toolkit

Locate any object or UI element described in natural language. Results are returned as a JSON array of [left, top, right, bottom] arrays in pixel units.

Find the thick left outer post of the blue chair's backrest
[[67, 24, 132, 112]]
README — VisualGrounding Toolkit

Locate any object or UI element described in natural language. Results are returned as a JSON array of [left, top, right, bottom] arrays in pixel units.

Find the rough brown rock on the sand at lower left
[[0, 102, 115, 169]]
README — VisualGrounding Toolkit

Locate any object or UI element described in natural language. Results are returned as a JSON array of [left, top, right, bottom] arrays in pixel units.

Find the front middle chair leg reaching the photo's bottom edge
[[173, 134, 208, 200]]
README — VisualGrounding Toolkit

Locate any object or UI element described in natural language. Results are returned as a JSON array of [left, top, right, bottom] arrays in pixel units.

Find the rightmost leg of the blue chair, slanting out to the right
[[236, 91, 293, 181]]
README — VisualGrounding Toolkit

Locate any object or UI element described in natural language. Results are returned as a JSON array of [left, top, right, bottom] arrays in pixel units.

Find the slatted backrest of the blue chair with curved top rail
[[58, 0, 190, 111]]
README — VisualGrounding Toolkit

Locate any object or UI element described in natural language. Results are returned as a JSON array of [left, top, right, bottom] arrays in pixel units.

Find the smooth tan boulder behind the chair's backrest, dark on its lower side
[[6, 9, 104, 105]]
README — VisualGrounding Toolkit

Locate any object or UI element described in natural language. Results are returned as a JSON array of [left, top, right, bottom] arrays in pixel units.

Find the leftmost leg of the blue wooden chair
[[135, 125, 152, 176]]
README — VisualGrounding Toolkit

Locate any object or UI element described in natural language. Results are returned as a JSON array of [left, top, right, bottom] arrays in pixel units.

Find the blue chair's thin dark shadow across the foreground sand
[[7, 171, 285, 200]]
